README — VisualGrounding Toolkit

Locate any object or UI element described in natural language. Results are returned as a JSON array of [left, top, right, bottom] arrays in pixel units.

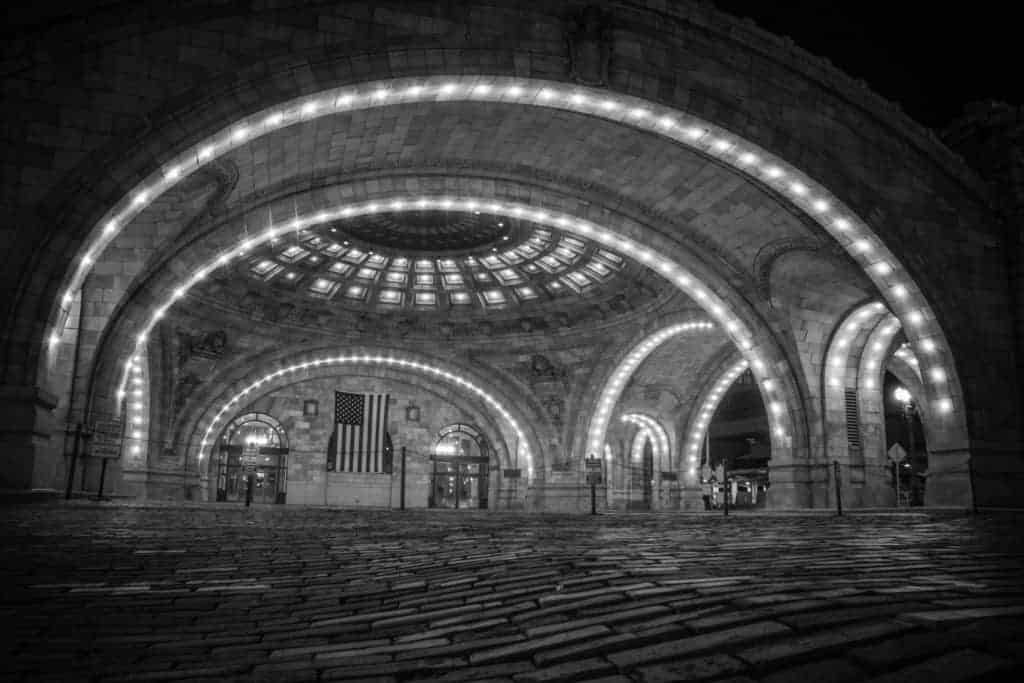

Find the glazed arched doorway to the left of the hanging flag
[[217, 413, 289, 504]]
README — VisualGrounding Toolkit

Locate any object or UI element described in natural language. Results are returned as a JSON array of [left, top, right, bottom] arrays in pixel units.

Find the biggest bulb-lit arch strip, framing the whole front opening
[[43, 75, 965, 438]]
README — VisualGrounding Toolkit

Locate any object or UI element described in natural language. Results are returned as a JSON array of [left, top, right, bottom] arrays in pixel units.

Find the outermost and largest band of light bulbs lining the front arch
[[34, 77, 964, 458]]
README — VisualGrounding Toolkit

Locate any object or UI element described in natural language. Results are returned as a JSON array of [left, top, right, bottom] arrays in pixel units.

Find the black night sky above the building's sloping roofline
[[714, 0, 1024, 129]]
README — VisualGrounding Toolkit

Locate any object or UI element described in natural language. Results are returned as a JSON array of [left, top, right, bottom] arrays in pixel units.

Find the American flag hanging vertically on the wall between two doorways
[[332, 391, 390, 472]]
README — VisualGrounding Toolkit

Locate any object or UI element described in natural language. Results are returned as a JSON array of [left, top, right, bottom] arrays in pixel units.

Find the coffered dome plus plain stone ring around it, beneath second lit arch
[[188, 211, 672, 333]]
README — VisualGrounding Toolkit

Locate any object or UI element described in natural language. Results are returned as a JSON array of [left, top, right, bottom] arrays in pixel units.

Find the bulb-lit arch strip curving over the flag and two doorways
[[199, 353, 534, 477]]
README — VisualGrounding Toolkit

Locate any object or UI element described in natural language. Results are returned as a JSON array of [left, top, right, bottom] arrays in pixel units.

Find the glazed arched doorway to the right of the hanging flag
[[427, 424, 490, 510]]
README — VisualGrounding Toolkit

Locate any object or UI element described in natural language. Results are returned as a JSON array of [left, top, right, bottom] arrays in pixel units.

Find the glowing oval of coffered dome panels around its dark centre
[[236, 212, 636, 312]]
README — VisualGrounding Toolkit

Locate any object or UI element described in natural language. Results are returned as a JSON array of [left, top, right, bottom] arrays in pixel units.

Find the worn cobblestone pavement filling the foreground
[[0, 503, 1024, 683]]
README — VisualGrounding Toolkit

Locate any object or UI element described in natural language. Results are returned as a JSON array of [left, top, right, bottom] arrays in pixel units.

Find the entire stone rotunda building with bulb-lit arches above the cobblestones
[[0, 2, 1024, 512]]
